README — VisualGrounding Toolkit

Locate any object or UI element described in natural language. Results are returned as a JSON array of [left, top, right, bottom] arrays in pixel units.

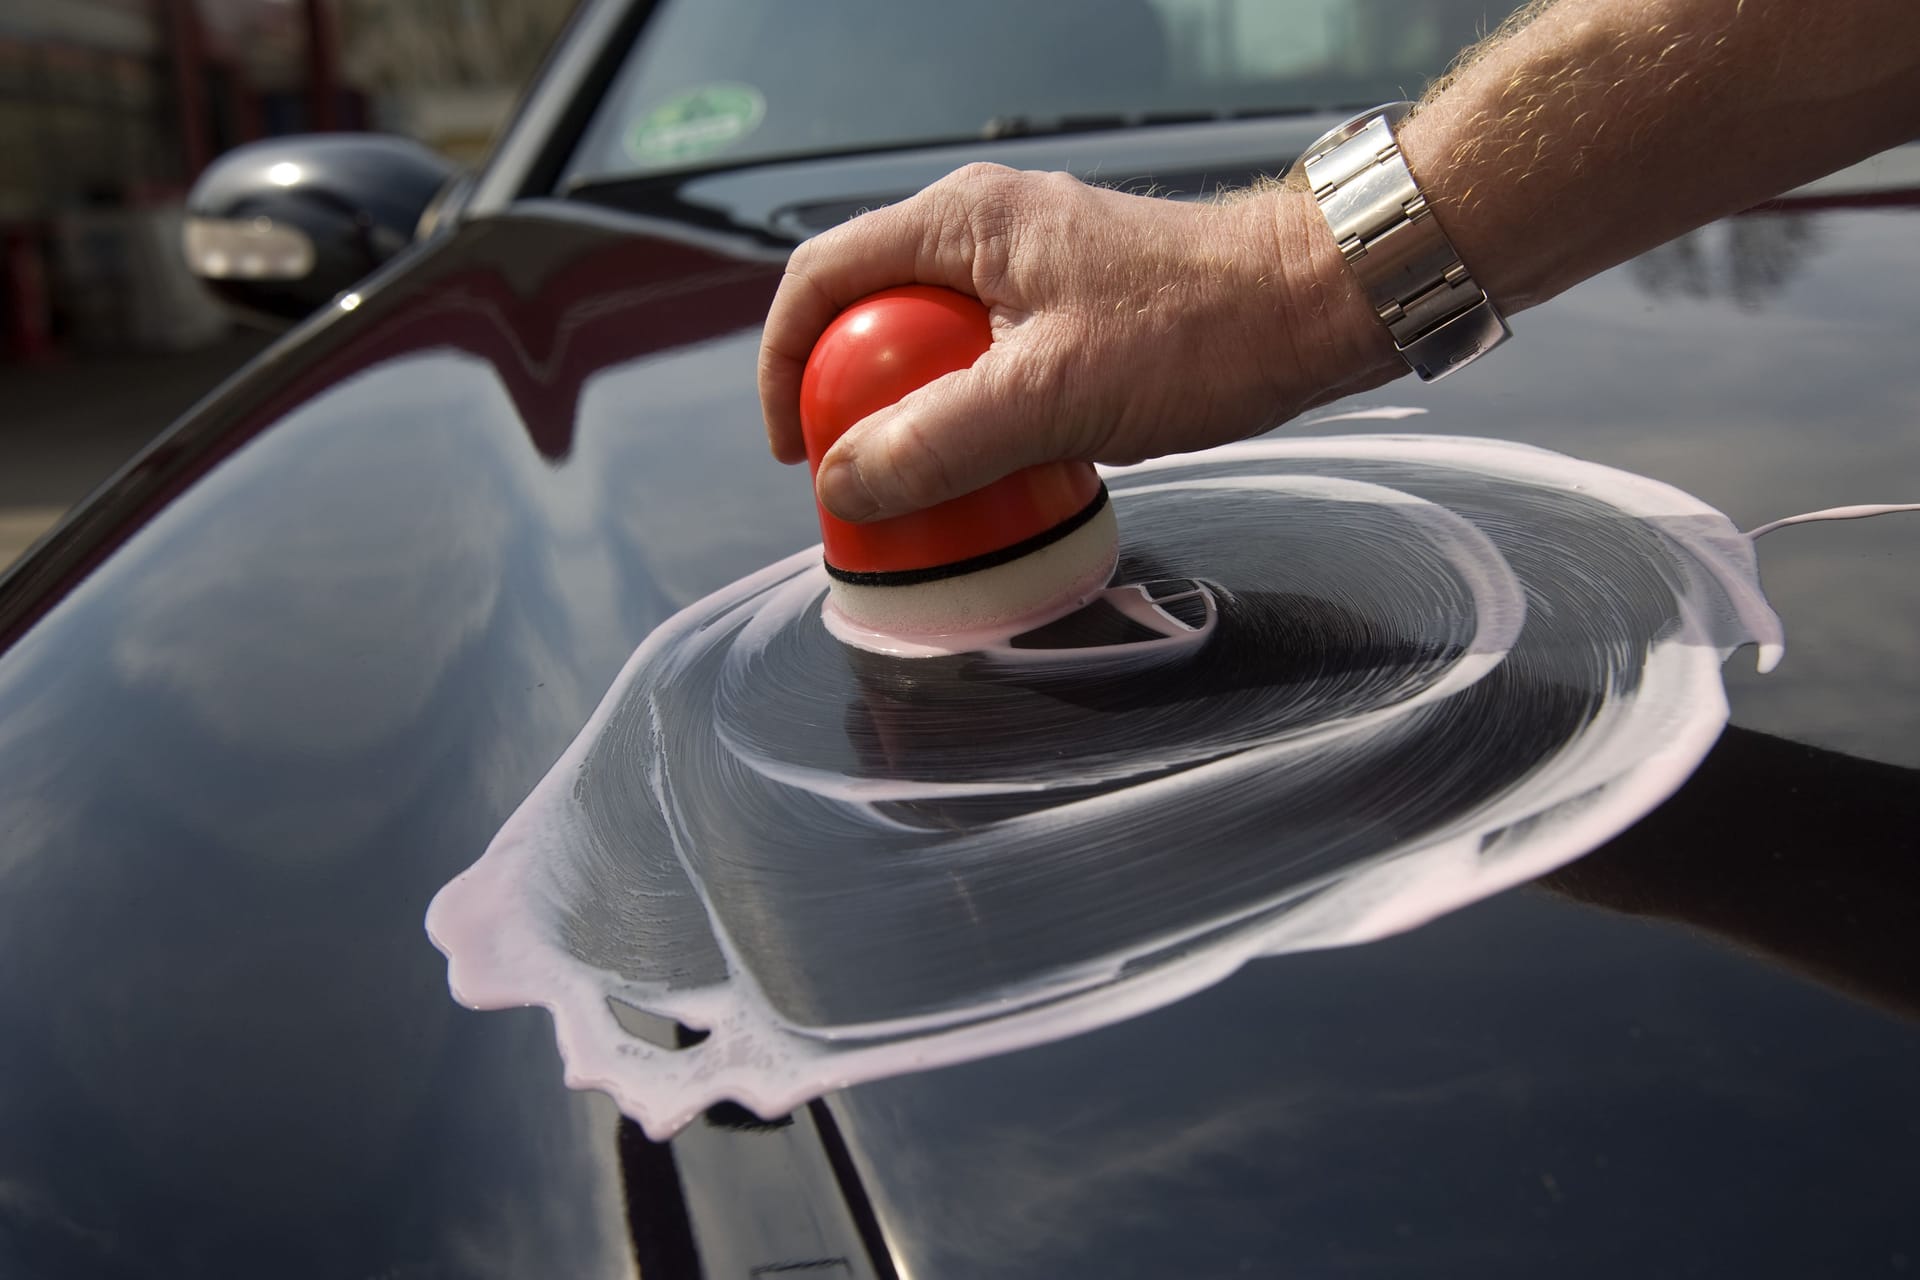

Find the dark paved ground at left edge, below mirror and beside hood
[[0, 332, 269, 568]]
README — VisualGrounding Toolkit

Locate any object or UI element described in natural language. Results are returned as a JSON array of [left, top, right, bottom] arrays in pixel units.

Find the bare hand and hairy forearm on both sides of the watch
[[760, 0, 1920, 520]]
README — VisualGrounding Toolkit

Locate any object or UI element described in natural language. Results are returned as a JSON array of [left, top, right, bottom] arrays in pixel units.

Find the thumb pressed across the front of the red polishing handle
[[814, 349, 1064, 522]]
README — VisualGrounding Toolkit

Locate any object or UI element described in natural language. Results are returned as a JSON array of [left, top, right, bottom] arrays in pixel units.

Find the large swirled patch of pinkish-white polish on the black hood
[[428, 436, 1780, 1136]]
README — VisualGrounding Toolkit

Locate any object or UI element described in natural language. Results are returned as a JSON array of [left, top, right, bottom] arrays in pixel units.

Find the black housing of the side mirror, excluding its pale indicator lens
[[186, 134, 455, 320]]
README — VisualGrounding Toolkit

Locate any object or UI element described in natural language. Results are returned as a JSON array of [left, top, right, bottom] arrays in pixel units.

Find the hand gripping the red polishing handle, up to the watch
[[760, 165, 1404, 520]]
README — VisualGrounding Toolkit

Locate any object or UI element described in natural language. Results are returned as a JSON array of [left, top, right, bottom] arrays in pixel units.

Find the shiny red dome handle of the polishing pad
[[801, 284, 1100, 574]]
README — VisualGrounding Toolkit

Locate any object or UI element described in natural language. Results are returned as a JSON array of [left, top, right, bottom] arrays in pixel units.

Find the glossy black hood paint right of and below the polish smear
[[817, 180, 1920, 1276]]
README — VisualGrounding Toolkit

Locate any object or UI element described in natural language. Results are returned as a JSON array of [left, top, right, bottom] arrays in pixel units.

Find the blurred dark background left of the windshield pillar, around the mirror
[[0, 0, 574, 566]]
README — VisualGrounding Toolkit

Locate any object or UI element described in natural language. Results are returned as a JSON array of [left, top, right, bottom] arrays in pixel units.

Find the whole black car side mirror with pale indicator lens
[[184, 134, 455, 320]]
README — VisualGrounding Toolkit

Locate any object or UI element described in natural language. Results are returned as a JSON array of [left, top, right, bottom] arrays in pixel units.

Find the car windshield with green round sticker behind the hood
[[563, 0, 1515, 186]]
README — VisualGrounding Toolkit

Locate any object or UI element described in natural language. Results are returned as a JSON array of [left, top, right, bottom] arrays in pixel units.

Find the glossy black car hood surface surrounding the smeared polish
[[0, 152, 1920, 1276]]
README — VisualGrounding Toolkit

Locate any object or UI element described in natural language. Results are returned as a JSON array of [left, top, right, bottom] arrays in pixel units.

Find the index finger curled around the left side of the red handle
[[758, 171, 1013, 462]]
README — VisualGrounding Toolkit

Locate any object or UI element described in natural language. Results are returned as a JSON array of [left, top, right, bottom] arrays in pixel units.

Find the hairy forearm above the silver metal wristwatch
[[1400, 0, 1920, 311]]
